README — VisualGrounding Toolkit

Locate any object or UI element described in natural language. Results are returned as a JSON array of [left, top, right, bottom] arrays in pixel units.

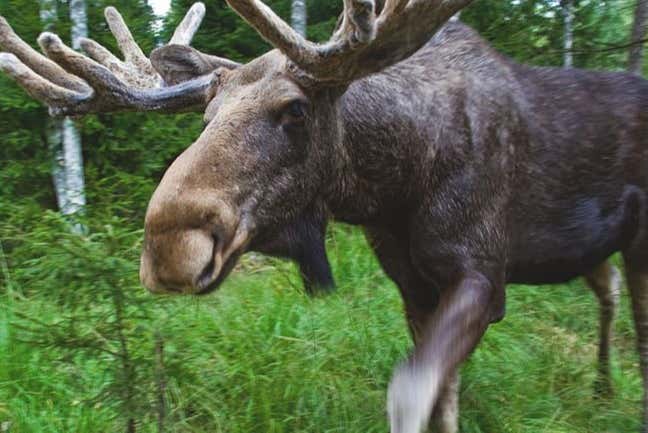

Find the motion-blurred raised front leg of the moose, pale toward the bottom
[[387, 272, 493, 433]]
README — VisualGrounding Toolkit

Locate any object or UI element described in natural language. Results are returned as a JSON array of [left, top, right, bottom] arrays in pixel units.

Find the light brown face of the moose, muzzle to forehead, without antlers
[[140, 51, 332, 294]]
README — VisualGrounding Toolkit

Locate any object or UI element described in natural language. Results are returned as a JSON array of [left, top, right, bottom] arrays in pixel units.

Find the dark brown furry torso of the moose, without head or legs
[[334, 19, 648, 314]]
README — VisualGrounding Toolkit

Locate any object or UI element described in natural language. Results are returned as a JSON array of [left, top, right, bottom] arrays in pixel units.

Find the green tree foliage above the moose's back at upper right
[[461, 0, 635, 70]]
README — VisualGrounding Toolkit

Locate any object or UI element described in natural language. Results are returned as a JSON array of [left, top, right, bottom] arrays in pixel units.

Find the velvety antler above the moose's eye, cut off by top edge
[[227, 0, 472, 83]]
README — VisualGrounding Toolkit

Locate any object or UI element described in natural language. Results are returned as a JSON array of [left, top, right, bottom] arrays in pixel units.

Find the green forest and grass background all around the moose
[[0, 0, 648, 433]]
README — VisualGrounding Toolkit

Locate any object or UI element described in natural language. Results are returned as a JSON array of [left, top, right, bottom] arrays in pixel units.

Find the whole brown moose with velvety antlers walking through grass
[[0, 0, 648, 433]]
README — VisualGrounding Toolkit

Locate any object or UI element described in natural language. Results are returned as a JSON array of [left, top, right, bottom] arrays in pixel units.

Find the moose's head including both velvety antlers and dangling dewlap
[[0, 0, 470, 294]]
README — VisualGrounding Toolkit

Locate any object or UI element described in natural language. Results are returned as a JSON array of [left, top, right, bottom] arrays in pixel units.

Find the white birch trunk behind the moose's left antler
[[61, 0, 88, 223]]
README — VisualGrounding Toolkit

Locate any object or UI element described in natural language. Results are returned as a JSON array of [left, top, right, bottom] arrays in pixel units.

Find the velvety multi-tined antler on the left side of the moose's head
[[0, 3, 224, 115]]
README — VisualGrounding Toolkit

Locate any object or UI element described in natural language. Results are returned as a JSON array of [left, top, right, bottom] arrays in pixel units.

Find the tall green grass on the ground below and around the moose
[[0, 223, 641, 433]]
